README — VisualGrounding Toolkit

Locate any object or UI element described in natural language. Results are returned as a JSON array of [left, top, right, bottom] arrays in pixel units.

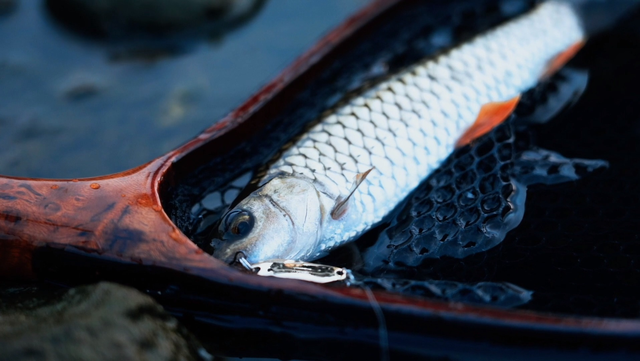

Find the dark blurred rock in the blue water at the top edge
[[45, 0, 264, 36]]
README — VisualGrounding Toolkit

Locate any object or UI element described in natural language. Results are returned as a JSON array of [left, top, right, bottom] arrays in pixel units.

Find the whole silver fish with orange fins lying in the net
[[212, 1, 586, 264]]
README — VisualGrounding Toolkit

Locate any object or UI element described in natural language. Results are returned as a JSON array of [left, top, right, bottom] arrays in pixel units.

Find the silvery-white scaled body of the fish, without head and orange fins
[[261, 2, 584, 248]]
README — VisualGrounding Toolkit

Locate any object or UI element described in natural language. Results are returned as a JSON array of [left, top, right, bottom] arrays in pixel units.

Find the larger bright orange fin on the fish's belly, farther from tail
[[456, 95, 520, 148]]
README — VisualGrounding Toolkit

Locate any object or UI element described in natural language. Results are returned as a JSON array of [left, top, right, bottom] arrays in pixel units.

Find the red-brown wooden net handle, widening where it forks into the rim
[[0, 157, 217, 278]]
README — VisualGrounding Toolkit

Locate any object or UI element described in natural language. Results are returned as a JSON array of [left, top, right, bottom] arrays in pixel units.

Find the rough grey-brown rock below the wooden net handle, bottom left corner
[[0, 283, 202, 361]]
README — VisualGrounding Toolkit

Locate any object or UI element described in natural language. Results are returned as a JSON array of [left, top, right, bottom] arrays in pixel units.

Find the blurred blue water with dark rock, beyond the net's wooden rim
[[0, 0, 369, 178]]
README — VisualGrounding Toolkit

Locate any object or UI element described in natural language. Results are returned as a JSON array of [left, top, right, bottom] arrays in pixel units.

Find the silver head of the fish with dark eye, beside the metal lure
[[212, 176, 325, 264]]
